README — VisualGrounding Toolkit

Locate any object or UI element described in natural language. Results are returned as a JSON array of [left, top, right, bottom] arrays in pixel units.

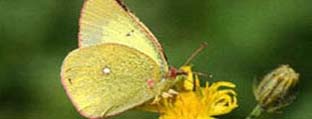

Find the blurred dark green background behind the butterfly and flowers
[[0, 0, 312, 119]]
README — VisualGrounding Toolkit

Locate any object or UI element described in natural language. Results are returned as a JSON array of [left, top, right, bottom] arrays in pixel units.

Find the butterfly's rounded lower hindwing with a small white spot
[[61, 44, 161, 118]]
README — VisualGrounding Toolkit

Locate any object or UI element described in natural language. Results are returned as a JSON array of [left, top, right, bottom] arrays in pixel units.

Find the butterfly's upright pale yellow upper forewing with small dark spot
[[79, 0, 168, 72]]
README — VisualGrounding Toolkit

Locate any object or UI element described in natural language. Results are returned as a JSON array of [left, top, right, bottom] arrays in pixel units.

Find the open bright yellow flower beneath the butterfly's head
[[143, 66, 238, 119]]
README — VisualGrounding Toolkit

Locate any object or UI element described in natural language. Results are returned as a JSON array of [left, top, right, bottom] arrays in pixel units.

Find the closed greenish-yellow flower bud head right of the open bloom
[[254, 65, 299, 112]]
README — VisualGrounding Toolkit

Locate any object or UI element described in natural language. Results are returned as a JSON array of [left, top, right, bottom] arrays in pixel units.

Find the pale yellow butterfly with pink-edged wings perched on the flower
[[61, 0, 193, 118]]
